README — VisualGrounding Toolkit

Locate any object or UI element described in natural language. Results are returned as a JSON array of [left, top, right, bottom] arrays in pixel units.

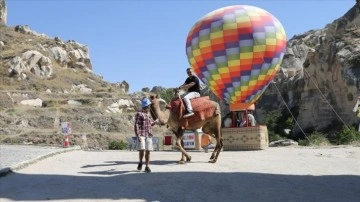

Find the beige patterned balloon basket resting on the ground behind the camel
[[221, 125, 269, 151]]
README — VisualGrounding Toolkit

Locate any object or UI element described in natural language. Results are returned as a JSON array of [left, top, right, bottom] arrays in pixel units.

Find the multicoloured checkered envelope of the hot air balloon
[[186, 5, 286, 111]]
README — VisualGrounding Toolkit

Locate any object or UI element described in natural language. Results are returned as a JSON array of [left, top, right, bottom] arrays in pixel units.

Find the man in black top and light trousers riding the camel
[[178, 68, 200, 118]]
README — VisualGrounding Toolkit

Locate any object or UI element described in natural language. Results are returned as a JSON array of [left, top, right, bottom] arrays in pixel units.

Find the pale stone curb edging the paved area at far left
[[0, 146, 81, 177]]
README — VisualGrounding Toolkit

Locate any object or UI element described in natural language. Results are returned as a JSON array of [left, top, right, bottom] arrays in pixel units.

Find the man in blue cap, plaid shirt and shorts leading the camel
[[134, 97, 158, 173]]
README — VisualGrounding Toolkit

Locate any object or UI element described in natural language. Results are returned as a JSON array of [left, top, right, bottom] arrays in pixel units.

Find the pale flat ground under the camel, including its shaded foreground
[[0, 147, 360, 202]]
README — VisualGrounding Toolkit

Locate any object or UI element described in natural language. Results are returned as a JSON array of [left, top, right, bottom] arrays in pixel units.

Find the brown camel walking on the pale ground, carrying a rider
[[150, 92, 223, 164]]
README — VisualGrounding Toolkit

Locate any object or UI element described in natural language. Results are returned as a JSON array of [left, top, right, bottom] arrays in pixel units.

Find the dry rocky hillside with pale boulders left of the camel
[[0, 17, 166, 149]]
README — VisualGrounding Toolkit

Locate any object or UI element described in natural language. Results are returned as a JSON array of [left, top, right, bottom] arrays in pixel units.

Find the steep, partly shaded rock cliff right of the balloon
[[257, 4, 360, 134]]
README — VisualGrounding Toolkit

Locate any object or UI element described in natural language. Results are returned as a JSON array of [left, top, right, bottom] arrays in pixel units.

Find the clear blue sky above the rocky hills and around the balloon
[[6, 0, 355, 93]]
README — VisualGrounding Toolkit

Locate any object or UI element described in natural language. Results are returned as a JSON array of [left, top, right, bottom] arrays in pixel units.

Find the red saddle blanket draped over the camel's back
[[166, 96, 217, 128]]
